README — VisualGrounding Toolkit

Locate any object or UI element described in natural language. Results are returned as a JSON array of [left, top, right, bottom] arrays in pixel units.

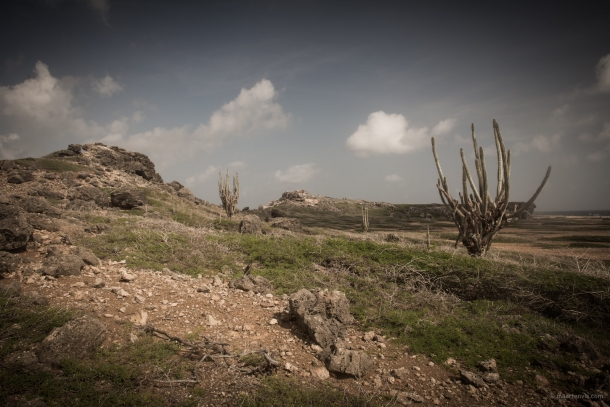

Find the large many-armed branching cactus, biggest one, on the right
[[432, 119, 551, 257]]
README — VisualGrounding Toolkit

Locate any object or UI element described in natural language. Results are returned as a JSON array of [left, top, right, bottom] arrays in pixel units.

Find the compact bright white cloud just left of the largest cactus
[[346, 111, 430, 156]]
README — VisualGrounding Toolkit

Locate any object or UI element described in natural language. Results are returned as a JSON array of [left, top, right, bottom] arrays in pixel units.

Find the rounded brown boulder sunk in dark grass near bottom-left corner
[[36, 315, 106, 366]]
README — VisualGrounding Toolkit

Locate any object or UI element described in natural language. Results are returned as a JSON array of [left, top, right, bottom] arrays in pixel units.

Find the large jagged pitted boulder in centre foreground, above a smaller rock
[[289, 288, 354, 353]]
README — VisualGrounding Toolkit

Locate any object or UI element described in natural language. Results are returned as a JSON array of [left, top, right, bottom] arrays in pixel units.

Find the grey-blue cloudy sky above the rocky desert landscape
[[0, 0, 610, 211]]
